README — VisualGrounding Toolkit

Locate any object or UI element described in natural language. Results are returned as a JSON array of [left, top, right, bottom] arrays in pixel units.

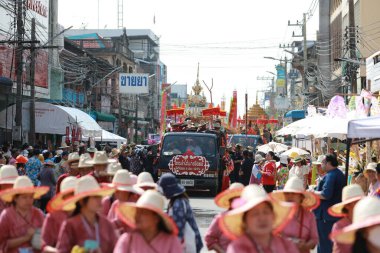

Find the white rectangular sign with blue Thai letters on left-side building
[[119, 73, 149, 94]]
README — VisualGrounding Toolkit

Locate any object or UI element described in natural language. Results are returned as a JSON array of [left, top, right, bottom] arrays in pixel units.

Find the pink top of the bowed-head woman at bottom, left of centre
[[113, 232, 183, 253]]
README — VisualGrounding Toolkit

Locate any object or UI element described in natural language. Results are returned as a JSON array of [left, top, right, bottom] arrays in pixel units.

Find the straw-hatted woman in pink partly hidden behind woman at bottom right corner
[[328, 184, 364, 253]]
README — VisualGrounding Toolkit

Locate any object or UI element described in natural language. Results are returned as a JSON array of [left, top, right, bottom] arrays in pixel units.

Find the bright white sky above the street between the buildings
[[58, 0, 319, 115]]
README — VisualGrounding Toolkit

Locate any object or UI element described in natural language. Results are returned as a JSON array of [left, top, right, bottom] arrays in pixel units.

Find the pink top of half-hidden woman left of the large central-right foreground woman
[[205, 214, 231, 251]]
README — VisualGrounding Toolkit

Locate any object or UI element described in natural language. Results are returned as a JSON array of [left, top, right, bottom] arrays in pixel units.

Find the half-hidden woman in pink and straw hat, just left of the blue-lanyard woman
[[41, 176, 78, 253]]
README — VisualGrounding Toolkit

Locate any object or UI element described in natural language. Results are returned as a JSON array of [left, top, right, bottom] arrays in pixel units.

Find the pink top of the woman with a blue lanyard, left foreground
[[57, 214, 118, 253]]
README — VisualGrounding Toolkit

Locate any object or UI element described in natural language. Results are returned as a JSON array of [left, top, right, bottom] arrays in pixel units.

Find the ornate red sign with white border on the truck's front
[[169, 151, 210, 176]]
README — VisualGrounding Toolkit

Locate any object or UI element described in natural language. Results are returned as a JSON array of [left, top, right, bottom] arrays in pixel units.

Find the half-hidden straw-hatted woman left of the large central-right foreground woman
[[205, 183, 244, 253]]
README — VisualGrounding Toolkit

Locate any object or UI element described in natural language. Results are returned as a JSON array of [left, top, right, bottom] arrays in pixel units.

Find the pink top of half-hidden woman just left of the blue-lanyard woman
[[41, 211, 69, 249]]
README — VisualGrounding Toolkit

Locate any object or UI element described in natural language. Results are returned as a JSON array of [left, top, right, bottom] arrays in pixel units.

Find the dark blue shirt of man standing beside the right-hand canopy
[[314, 169, 345, 221]]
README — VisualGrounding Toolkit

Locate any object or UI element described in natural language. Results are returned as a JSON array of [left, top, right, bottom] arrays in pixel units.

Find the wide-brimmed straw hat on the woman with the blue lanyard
[[61, 175, 115, 211]]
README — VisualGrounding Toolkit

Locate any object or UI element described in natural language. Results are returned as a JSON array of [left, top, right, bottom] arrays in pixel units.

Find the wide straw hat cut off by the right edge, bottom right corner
[[330, 196, 380, 244]]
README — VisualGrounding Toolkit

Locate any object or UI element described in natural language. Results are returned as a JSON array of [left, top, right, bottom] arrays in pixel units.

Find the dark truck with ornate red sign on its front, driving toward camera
[[158, 132, 225, 195]]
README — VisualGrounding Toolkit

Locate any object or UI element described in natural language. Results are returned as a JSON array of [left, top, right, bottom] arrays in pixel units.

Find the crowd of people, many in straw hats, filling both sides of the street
[[0, 140, 380, 253]]
